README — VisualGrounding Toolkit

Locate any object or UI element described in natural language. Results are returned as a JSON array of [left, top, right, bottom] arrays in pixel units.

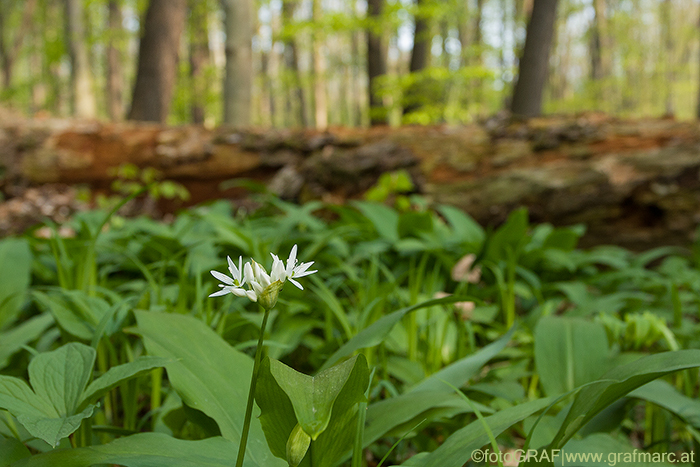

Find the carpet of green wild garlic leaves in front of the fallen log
[[0, 188, 700, 467]]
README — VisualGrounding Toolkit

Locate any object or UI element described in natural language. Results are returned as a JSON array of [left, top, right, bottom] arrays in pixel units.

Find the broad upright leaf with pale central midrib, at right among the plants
[[535, 316, 609, 396]]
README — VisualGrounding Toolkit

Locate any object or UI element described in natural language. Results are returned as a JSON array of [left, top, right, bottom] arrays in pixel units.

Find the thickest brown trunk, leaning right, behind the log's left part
[[129, 0, 187, 122]]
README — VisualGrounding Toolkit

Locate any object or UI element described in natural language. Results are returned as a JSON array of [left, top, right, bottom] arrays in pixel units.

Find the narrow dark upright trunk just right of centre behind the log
[[367, 0, 387, 125]]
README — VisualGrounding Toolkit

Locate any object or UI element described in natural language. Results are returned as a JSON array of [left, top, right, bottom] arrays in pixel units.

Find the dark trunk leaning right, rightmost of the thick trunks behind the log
[[511, 0, 557, 117]]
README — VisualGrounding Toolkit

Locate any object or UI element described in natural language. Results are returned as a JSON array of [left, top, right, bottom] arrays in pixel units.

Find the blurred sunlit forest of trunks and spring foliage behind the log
[[0, 0, 700, 128]]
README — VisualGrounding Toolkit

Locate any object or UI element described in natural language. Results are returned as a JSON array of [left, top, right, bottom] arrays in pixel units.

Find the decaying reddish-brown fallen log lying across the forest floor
[[0, 110, 700, 248]]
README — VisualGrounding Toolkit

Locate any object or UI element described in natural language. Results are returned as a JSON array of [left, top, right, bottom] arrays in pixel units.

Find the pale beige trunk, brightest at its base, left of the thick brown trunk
[[65, 0, 97, 118]]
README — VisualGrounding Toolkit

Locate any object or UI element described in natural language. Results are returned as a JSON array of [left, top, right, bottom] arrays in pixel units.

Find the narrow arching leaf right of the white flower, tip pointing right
[[321, 296, 469, 371]]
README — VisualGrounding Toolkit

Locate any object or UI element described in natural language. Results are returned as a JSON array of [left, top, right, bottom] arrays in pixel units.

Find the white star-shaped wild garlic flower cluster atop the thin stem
[[209, 245, 317, 309]]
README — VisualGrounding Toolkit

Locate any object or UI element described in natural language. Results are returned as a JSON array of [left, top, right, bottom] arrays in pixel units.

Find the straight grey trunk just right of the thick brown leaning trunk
[[222, 0, 253, 127]]
